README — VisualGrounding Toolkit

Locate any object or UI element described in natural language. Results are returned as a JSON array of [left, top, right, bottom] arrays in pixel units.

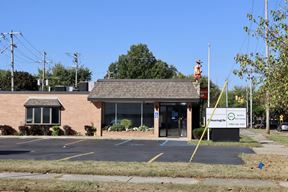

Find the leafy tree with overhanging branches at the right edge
[[235, 1, 288, 111]]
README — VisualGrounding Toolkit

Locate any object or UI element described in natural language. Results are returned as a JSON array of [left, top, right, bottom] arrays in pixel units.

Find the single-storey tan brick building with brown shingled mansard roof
[[0, 79, 200, 139]]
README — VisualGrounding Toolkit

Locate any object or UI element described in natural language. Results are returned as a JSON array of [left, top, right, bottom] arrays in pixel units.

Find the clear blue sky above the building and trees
[[0, 0, 282, 88]]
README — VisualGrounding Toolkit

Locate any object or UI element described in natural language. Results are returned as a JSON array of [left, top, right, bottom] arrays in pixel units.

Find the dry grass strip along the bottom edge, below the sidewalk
[[0, 180, 287, 192]]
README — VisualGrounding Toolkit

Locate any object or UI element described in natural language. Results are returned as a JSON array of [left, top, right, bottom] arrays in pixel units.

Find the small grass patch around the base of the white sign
[[189, 135, 261, 147]]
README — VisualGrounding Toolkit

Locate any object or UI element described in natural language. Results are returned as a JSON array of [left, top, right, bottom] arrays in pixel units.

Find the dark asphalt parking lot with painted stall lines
[[0, 138, 254, 165]]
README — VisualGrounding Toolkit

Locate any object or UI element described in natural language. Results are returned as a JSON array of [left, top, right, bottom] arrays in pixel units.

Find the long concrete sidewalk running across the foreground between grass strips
[[0, 172, 288, 188]]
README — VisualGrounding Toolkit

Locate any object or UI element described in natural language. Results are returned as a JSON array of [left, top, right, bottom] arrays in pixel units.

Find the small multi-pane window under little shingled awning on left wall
[[26, 107, 60, 125]]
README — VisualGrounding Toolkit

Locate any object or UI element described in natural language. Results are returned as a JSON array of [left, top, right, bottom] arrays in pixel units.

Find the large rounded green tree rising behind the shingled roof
[[105, 44, 177, 79]]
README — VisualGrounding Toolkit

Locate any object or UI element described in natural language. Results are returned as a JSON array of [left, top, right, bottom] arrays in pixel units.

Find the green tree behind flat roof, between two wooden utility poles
[[38, 63, 92, 88]]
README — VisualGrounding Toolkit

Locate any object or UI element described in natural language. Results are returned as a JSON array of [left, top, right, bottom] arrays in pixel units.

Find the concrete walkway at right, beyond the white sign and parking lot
[[241, 128, 288, 156]]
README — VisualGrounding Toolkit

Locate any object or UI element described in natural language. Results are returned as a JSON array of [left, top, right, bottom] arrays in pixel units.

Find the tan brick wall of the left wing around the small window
[[0, 93, 101, 134]]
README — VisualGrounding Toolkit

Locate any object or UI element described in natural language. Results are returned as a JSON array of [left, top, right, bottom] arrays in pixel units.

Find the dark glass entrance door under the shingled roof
[[159, 103, 187, 137]]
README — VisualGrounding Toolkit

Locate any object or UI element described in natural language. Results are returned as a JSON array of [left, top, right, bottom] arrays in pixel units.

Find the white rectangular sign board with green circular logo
[[206, 108, 247, 128]]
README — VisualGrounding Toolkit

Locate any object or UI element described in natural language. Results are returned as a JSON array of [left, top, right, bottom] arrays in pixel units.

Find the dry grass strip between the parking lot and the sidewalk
[[0, 154, 288, 180]]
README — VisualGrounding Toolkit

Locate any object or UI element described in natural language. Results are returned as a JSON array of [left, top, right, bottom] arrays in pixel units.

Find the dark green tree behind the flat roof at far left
[[0, 70, 38, 91]]
